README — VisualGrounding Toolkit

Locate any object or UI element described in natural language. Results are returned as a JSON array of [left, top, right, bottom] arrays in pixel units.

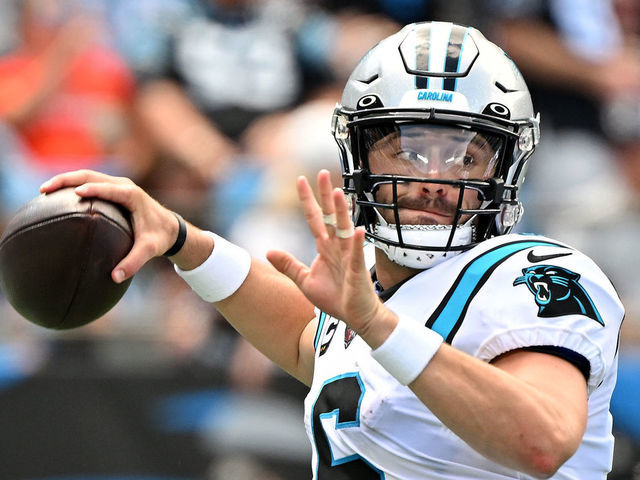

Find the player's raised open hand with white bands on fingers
[[267, 170, 388, 340]]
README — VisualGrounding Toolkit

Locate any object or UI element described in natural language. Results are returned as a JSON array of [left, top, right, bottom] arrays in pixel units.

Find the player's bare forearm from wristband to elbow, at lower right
[[410, 344, 586, 477]]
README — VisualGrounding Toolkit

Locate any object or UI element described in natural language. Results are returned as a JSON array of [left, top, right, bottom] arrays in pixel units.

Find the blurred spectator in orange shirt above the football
[[0, 0, 138, 216]]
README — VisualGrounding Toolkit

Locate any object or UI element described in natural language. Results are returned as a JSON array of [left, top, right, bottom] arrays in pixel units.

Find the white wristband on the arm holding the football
[[174, 232, 251, 302]]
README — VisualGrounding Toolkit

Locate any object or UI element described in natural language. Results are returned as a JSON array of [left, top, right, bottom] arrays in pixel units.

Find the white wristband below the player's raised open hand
[[371, 316, 443, 385]]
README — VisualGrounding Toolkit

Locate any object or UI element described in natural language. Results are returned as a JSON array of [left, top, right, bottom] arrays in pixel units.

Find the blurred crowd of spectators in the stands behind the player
[[0, 0, 640, 480]]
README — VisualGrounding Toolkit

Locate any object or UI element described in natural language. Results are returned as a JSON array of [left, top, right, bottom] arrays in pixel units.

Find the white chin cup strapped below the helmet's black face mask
[[373, 224, 474, 269]]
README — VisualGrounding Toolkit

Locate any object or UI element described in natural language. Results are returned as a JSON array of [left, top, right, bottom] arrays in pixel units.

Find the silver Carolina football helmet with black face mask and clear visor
[[332, 22, 540, 268]]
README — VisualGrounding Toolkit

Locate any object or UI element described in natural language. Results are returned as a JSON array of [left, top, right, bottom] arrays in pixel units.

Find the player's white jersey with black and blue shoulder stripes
[[305, 234, 624, 480]]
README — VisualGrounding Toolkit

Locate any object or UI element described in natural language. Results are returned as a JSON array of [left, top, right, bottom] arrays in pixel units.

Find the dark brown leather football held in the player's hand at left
[[0, 188, 133, 329]]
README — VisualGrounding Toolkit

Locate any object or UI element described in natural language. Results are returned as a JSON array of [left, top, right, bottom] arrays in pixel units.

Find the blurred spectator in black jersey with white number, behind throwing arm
[[105, 0, 312, 223]]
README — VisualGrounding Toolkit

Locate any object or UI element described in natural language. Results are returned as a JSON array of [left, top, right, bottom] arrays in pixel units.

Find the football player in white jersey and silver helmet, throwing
[[42, 22, 624, 480]]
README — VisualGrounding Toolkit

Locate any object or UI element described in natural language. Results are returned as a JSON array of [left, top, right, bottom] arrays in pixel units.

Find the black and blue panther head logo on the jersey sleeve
[[513, 265, 604, 326]]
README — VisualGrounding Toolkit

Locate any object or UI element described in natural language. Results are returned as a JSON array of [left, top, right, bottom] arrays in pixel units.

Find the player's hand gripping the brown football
[[40, 170, 178, 283]]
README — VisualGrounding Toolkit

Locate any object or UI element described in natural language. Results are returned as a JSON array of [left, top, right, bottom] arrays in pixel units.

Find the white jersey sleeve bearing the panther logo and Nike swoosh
[[473, 247, 624, 393]]
